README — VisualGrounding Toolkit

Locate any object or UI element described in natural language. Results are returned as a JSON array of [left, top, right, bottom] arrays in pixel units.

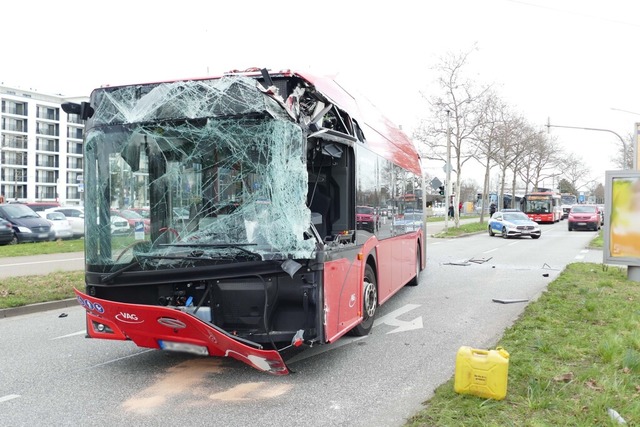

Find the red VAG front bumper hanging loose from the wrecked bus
[[75, 289, 289, 375]]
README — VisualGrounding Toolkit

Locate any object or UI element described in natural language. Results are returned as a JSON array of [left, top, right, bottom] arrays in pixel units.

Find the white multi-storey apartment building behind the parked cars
[[0, 84, 89, 204]]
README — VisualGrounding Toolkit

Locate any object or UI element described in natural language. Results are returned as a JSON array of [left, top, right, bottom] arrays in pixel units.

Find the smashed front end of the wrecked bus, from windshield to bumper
[[77, 76, 340, 374]]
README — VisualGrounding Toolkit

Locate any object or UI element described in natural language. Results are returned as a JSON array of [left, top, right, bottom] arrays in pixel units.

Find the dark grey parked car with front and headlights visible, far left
[[0, 203, 55, 243]]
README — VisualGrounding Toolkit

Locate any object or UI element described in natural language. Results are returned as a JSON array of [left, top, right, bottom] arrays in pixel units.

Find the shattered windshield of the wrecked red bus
[[85, 77, 315, 268]]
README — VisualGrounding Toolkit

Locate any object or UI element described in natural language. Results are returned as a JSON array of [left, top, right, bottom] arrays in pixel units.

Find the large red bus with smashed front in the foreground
[[63, 69, 426, 375]]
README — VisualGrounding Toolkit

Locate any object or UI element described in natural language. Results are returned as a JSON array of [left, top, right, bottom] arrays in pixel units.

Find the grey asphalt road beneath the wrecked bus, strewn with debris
[[0, 222, 602, 427]]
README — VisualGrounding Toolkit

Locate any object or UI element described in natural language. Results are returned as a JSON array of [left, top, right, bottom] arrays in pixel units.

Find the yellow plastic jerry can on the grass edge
[[454, 346, 509, 400]]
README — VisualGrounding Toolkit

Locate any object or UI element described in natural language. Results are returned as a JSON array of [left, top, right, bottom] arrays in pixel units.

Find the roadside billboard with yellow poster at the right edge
[[603, 170, 640, 267]]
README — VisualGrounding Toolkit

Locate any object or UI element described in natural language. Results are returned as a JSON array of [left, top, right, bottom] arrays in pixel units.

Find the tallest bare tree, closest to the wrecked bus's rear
[[414, 46, 488, 227]]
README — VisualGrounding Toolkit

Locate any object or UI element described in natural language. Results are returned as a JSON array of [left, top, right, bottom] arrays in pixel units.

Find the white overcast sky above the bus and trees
[[0, 0, 640, 189]]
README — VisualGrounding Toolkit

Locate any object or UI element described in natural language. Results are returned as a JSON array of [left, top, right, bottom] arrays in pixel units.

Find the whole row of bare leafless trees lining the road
[[413, 50, 633, 226]]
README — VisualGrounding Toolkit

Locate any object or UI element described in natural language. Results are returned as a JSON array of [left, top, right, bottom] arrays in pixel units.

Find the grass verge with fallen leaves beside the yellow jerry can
[[406, 263, 640, 427]]
